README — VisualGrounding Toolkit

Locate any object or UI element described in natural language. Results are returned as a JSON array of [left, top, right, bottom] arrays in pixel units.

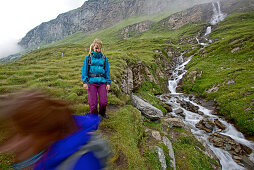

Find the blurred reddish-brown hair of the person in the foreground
[[0, 90, 76, 155]]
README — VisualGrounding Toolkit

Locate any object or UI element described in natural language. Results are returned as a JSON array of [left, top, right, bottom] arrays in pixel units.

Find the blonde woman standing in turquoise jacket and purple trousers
[[82, 39, 111, 118]]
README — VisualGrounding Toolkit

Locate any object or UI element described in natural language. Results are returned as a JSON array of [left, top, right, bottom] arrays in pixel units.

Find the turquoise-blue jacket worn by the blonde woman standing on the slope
[[82, 51, 111, 84]]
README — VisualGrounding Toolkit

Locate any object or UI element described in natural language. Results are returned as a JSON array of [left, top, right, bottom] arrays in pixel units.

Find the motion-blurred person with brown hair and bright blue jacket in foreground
[[0, 90, 110, 170]]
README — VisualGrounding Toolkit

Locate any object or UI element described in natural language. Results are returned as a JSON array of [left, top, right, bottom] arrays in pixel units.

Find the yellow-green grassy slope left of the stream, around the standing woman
[[0, 9, 252, 169]]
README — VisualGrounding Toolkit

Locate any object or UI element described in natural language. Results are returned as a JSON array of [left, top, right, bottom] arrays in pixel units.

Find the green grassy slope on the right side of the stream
[[184, 12, 254, 136]]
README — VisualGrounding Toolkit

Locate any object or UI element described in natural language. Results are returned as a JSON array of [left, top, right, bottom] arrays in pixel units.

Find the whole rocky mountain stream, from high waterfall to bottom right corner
[[159, 2, 254, 170]]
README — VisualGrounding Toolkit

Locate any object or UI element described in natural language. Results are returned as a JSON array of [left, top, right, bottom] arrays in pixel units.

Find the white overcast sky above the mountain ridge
[[0, 0, 86, 58]]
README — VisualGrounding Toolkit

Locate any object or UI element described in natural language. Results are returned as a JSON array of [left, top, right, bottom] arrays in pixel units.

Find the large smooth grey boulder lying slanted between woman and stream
[[131, 95, 163, 120]]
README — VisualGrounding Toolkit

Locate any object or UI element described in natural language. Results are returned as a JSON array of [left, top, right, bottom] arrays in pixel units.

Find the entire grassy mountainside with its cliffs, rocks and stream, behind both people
[[0, 0, 254, 170]]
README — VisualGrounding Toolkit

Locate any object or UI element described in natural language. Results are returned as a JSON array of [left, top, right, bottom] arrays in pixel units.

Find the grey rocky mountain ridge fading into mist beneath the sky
[[19, 0, 217, 48]]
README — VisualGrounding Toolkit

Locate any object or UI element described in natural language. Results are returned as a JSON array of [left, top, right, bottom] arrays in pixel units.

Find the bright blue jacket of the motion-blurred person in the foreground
[[34, 114, 103, 170]]
